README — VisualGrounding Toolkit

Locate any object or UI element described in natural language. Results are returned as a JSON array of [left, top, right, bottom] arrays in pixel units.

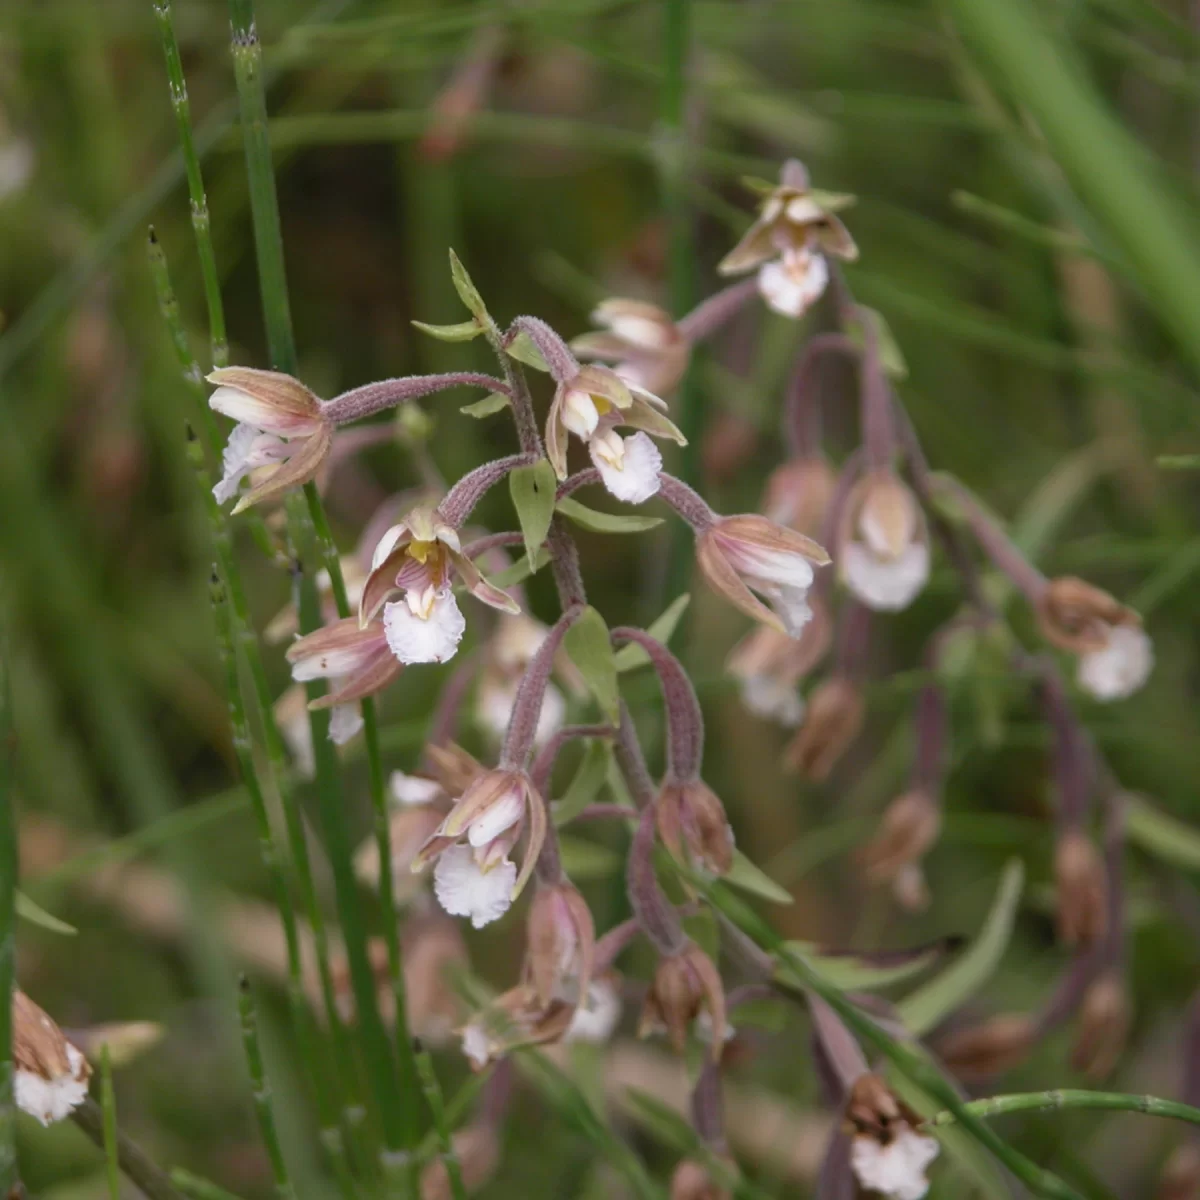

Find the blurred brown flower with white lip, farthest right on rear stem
[[1037, 576, 1154, 700]]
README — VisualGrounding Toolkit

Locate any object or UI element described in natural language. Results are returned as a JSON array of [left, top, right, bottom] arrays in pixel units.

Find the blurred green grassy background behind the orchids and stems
[[0, 0, 1200, 1198]]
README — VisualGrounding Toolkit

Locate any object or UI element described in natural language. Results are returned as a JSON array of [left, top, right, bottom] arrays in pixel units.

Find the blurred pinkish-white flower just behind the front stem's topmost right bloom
[[571, 298, 690, 396]]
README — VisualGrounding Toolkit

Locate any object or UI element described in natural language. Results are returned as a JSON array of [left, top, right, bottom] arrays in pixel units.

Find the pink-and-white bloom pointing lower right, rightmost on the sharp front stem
[[696, 512, 829, 637]]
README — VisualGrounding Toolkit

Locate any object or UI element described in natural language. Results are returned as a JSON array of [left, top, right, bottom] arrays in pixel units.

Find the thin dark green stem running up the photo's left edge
[[0, 640, 19, 1196]]
